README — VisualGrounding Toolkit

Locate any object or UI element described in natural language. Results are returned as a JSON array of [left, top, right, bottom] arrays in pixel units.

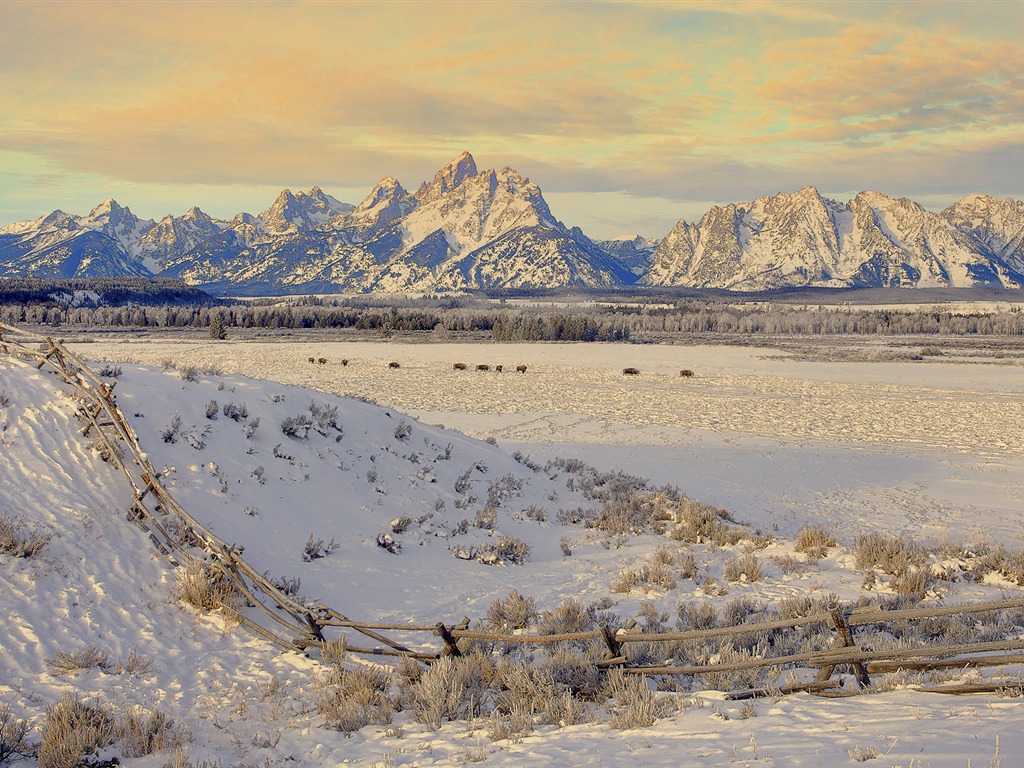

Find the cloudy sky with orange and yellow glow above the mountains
[[0, 0, 1024, 239]]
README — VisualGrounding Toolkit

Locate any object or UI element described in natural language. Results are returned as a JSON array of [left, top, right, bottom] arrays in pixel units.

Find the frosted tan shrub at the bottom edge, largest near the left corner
[[36, 693, 116, 768]]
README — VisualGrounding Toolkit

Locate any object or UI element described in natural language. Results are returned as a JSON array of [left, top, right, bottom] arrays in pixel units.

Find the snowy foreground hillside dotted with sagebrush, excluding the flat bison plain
[[6, 342, 1024, 768]]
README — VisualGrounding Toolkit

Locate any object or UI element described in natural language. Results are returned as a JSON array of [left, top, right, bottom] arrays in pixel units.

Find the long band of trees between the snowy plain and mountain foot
[[0, 279, 1024, 341]]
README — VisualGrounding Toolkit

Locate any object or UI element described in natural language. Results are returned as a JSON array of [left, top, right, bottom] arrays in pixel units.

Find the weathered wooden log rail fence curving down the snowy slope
[[0, 324, 1024, 698]]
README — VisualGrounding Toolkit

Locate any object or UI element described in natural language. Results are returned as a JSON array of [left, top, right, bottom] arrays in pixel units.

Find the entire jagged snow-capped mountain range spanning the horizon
[[0, 153, 1024, 294]]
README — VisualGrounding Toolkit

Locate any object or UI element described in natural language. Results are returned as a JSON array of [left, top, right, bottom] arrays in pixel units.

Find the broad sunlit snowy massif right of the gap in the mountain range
[[644, 186, 1020, 290]]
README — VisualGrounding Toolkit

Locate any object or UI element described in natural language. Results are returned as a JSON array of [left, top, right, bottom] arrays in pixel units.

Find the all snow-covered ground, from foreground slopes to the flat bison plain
[[0, 337, 1024, 768]]
